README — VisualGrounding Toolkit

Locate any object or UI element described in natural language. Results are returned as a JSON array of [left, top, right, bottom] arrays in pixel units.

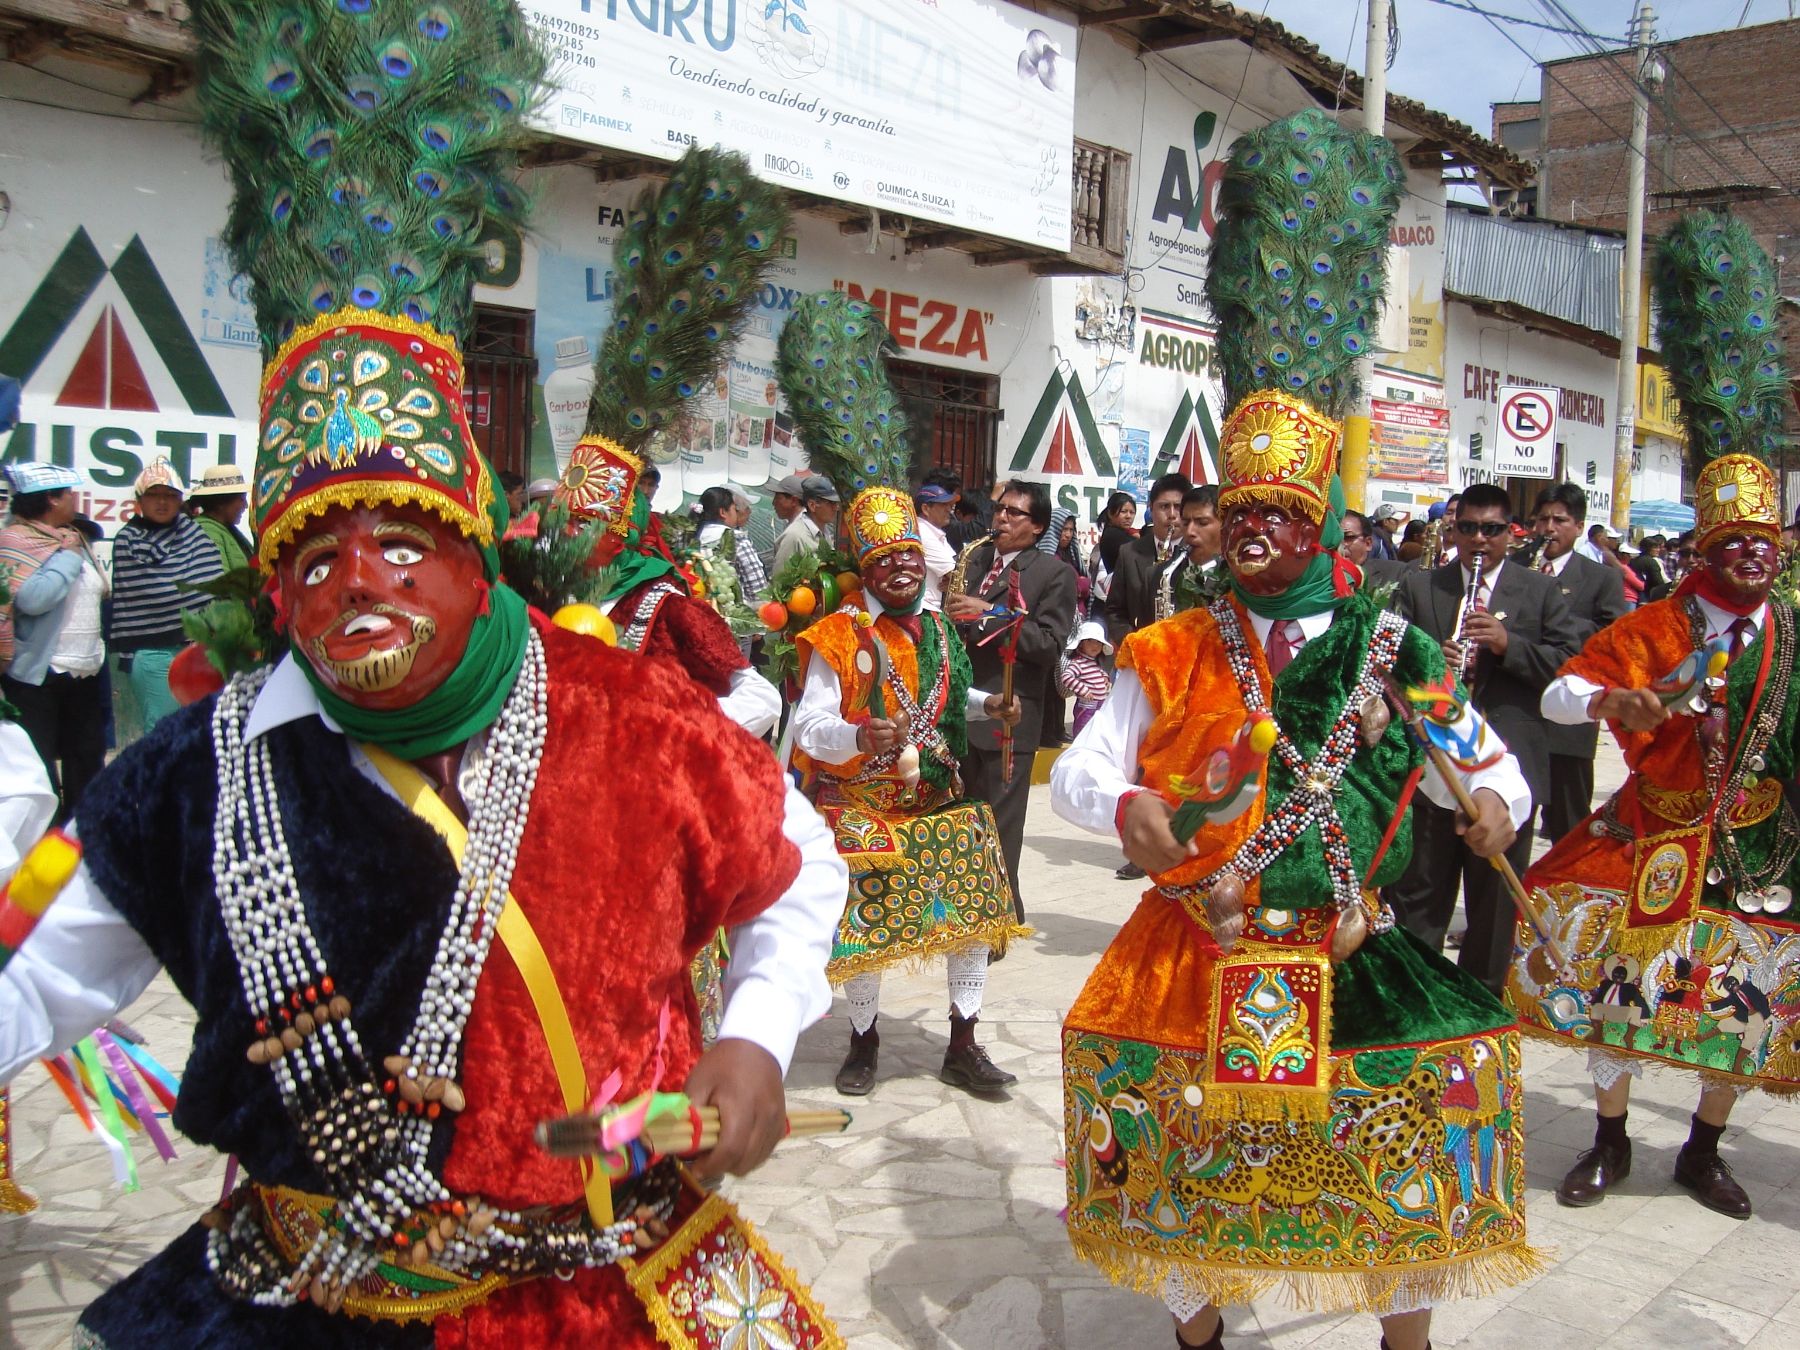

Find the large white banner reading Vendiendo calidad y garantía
[[526, 0, 1076, 250]]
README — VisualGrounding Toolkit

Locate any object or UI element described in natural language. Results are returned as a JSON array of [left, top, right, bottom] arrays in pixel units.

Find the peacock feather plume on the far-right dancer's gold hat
[[1651, 211, 1787, 463]]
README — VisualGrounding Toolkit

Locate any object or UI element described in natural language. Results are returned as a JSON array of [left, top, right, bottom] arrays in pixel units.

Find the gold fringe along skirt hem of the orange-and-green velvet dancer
[[1069, 1229, 1552, 1316]]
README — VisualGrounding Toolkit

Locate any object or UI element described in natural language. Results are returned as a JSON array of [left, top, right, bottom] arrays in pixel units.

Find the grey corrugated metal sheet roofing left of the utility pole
[[1444, 205, 1625, 338]]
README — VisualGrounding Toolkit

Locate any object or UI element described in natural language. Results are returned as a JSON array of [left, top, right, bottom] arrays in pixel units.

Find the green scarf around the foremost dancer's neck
[[292, 585, 531, 760]]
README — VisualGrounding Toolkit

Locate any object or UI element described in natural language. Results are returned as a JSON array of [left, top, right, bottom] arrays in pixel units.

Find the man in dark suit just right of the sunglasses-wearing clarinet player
[[1534, 482, 1625, 842]]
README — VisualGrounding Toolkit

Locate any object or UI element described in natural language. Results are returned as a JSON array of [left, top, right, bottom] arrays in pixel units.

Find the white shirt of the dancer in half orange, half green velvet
[[1049, 610, 1532, 837]]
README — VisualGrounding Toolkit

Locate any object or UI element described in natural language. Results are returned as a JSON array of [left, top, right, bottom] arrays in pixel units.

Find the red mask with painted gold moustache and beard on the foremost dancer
[[275, 506, 488, 711]]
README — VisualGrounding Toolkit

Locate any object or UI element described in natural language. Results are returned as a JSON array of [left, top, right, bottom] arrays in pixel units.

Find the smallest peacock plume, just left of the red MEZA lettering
[[776, 290, 913, 502]]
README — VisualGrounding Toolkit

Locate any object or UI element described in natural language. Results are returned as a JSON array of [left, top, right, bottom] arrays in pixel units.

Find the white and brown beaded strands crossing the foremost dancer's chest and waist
[[207, 634, 662, 1305]]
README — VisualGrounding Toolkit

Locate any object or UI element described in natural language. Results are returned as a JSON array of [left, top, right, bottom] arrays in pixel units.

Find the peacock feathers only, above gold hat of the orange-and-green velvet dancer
[[1206, 108, 1406, 419]]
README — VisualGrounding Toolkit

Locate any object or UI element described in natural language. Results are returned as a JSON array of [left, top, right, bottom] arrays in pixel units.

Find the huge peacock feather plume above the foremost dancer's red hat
[[193, 0, 545, 355]]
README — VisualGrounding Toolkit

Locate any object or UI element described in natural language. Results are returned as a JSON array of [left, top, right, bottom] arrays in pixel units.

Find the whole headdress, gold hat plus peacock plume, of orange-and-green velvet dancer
[[1206, 108, 1406, 522]]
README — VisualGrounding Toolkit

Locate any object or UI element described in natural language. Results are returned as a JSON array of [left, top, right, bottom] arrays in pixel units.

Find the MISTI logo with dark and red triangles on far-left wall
[[0, 229, 254, 520]]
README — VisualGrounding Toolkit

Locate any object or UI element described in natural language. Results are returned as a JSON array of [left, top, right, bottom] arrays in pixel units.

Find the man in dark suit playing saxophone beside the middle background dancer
[[943, 479, 1075, 920]]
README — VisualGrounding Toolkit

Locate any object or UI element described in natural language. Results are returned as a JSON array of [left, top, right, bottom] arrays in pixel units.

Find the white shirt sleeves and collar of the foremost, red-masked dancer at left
[[0, 655, 850, 1084]]
